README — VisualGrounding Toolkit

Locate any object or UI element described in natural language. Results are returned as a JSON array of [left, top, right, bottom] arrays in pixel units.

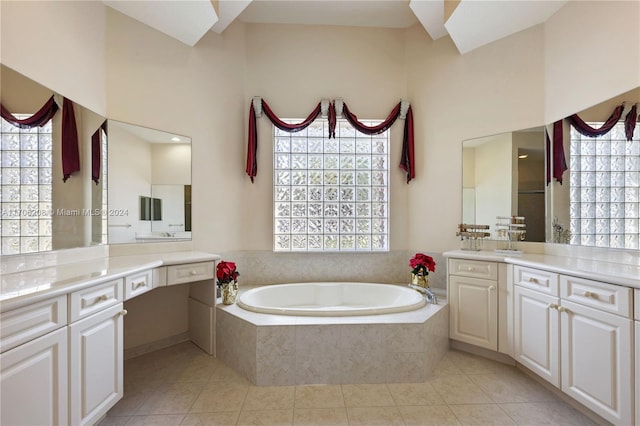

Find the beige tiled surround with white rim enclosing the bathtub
[[216, 290, 449, 386]]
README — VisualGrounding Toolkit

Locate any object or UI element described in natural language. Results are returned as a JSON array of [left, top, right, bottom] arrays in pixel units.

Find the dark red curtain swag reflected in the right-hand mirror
[[547, 103, 639, 184]]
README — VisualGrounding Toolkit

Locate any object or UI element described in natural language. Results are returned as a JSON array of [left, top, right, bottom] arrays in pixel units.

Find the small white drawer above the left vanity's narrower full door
[[69, 278, 123, 323]]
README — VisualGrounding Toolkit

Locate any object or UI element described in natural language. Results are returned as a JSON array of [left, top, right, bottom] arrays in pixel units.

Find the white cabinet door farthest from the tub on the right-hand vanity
[[559, 300, 634, 425]]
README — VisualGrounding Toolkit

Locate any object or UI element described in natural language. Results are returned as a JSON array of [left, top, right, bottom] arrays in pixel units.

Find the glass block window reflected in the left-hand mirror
[[0, 114, 53, 255]]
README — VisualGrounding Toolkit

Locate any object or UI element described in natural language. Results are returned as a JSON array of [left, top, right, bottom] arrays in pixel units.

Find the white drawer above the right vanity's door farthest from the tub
[[560, 275, 632, 318]]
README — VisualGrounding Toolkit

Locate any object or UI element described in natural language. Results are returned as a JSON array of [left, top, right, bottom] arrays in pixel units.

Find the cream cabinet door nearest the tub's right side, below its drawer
[[449, 275, 498, 351]]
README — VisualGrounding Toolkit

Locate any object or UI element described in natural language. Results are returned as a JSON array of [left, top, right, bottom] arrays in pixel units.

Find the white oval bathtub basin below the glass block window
[[237, 282, 426, 317]]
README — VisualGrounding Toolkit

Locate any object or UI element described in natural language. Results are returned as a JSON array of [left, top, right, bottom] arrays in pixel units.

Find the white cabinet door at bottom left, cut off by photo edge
[[0, 327, 68, 425]]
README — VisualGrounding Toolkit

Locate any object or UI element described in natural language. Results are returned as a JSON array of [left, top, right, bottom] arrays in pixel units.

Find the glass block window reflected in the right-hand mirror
[[569, 122, 640, 250]]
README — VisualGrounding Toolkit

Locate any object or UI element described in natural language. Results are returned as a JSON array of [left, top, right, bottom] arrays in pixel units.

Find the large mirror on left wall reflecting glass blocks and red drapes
[[0, 65, 106, 255]]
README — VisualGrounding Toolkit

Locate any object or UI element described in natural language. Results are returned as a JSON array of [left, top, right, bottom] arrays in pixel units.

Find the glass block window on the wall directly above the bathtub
[[273, 119, 389, 252]]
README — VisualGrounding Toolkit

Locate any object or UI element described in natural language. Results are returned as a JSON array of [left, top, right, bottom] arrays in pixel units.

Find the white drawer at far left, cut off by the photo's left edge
[[0, 295, 67, 352]]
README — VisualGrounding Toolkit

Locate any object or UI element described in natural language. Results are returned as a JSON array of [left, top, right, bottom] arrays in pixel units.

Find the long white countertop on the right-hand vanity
[[443, 250, 640, 288]]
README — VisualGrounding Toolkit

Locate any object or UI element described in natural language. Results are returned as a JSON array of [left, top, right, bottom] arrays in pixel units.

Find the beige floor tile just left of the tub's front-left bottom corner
[[189, 382, 249, 413]]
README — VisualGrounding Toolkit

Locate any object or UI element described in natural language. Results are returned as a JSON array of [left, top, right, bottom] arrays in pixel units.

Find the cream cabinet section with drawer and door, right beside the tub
[[447, 258, 512, 355]]
